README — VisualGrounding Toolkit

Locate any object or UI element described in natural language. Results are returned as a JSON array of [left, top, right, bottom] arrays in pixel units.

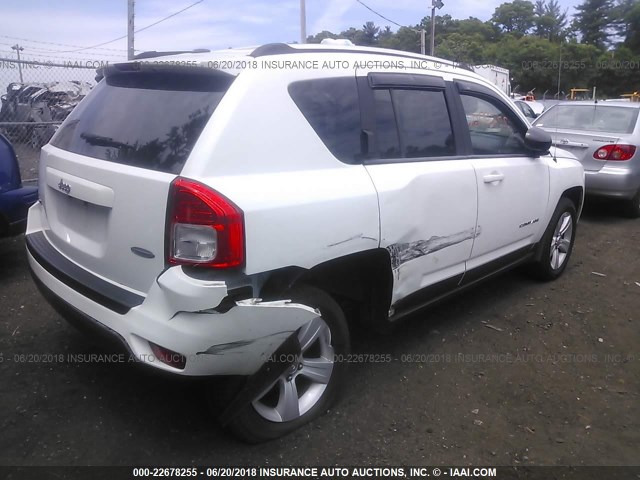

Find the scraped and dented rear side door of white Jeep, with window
[[358, 72, 477, 308]]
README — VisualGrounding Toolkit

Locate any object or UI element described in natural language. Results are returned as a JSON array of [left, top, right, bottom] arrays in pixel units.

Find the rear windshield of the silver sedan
[[535, 105, 638, 133]]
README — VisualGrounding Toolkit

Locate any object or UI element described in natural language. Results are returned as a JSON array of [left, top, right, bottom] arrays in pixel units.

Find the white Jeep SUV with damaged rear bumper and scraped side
[[26, 44, 584, 442]]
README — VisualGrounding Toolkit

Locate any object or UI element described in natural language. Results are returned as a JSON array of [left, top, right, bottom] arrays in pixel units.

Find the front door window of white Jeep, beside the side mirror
[[460, 94, 526, 155]]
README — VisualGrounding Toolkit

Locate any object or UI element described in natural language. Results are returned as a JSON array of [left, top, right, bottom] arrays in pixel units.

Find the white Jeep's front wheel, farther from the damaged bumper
[[530, 198, 578, 281]]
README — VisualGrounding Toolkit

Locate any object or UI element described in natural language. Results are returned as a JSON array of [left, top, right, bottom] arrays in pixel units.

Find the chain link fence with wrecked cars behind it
[[0, 56, 101, 180]]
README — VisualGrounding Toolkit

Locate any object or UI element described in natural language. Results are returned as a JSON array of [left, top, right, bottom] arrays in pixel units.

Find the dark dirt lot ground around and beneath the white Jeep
[[0, 193, 640, 466]]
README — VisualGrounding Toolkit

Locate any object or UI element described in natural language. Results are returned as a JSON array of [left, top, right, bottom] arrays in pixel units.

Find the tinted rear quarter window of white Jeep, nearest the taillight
[[289, 77, 362, 163]]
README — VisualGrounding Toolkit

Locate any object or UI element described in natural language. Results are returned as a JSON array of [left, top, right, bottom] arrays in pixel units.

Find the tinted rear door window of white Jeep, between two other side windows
[[374, 89, 456, 158]]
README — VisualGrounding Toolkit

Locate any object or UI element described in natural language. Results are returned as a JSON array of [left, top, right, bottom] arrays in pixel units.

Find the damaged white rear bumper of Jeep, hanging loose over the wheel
[[26, 222, 318, 376]]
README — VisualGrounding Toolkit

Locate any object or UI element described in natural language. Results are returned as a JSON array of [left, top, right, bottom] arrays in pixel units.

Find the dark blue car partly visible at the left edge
[[0, 135, 38, 237]]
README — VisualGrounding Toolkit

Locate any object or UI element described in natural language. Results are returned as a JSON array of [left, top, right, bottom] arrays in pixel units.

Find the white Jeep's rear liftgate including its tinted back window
[[39, 64, 234, 293]]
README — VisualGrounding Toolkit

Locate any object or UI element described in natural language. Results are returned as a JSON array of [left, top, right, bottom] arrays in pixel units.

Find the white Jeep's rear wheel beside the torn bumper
[[222, 286, 350, 443]]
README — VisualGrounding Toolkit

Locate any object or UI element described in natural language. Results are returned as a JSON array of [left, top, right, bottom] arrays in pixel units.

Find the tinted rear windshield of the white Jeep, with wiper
[[51, 69, 234, 174]]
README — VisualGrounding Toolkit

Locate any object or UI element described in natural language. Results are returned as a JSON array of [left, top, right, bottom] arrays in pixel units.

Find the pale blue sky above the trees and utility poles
[[0, 0, 579, 61]]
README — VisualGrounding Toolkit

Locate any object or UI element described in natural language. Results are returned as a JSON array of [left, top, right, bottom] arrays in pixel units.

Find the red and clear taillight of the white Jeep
[[166, 177, 244, 268]]
